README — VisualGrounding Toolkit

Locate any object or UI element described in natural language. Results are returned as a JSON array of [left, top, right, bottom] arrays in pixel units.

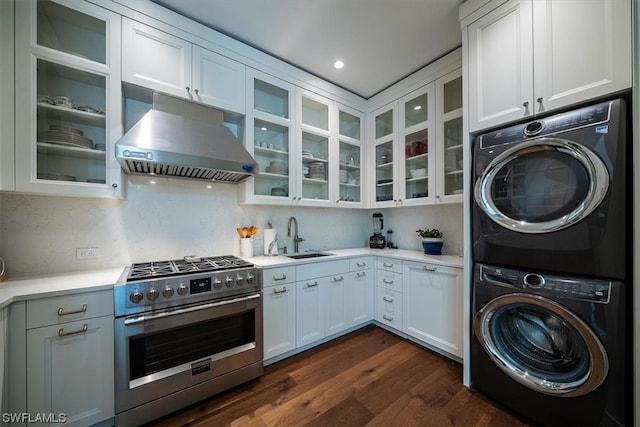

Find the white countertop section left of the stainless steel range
[[0, 267, 124, 308]]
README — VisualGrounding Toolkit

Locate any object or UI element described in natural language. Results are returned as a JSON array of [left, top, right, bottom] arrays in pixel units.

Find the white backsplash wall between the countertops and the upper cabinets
[[0, 176, 462, 278]]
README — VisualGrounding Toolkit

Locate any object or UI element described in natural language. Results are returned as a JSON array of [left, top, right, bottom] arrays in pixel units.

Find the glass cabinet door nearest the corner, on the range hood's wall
[[337, 106, 365, 207]]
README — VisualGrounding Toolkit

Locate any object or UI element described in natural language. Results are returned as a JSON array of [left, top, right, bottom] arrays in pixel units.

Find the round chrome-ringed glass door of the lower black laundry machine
[[474, 294, 609, 396]]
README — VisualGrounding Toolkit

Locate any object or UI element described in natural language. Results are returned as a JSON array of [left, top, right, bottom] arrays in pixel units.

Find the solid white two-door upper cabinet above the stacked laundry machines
[[463, 0, 632, 132]]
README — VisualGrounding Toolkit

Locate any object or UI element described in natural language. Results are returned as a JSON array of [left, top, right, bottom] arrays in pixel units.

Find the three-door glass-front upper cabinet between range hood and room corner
[[240, 68, 364, 207]]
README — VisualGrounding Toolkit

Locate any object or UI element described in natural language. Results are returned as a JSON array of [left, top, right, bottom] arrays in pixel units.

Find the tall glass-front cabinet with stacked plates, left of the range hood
[[16, 0, 122, 197]]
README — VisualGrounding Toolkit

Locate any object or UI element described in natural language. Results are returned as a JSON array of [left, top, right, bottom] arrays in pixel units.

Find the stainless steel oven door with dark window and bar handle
[[115, 293, 263, 413]]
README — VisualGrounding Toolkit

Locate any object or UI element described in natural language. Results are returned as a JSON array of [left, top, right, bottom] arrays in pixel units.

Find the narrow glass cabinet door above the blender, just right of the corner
[[371, 103, 398, 207]]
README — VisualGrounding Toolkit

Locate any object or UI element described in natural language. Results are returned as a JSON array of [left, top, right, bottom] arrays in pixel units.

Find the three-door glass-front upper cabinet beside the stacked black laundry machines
[[370, 63, 463, 207]]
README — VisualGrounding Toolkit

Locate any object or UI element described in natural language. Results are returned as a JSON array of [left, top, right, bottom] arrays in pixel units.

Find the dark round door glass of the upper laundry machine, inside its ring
[[491, 150, 590, 222]]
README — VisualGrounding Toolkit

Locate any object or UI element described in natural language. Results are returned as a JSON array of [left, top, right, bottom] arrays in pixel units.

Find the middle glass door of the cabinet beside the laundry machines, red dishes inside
[[398, 84, 435, 205]]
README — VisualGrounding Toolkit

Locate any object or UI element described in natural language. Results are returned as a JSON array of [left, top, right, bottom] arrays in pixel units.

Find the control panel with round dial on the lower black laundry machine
[[479, 265, 611, 304]]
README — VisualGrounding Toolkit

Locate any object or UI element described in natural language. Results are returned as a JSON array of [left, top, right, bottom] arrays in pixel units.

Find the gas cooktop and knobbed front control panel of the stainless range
[[114, 255, 262, 317]]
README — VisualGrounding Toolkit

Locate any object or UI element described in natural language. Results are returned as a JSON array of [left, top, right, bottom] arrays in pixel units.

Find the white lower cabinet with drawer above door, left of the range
[[26, 291, 114, 426]]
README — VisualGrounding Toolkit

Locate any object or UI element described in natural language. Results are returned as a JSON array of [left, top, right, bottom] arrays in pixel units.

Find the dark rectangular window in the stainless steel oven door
[[129, 310, 256, 380]]
